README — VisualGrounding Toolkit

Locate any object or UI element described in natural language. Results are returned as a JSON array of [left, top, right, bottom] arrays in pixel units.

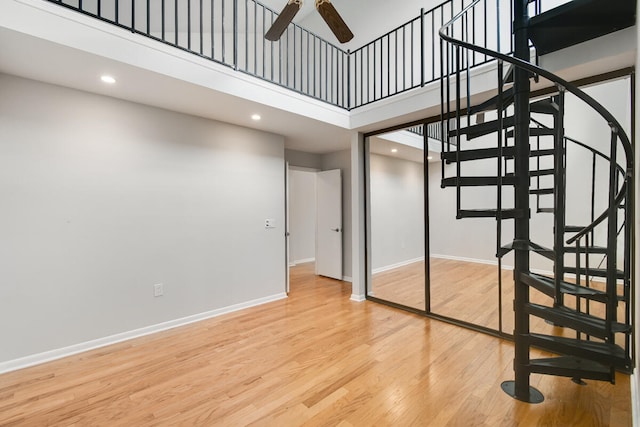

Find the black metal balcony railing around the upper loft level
[[46, 0, 566, 110]]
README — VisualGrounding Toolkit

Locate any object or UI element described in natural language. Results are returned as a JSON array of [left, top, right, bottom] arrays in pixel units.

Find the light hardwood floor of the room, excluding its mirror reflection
[[0, 265, 631, 426]]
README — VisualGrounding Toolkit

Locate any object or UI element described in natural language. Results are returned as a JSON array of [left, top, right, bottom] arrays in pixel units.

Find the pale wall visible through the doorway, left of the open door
[[289, 168, 316, 264]]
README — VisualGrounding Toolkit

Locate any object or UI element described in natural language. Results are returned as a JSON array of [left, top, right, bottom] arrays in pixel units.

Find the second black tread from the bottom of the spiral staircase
[[528, 333, 629, 369]]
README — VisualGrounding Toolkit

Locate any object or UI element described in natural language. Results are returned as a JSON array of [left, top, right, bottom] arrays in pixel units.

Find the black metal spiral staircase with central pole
[[440, 0, 635, 403]]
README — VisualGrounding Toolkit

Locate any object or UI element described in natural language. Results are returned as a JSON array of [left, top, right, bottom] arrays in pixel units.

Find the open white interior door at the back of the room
[[316, 169, 342, 280]]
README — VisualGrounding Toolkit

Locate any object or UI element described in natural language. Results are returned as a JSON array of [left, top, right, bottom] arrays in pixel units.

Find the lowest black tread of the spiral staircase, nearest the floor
[[528, 356, 615, 381]]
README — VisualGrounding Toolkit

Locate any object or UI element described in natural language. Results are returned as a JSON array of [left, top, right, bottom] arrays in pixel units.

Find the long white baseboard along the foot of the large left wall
[[0, 292, 287, 374]]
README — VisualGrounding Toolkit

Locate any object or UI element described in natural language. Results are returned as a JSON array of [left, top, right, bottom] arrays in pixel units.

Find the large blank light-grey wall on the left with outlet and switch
[[0, 75, 285, 364]]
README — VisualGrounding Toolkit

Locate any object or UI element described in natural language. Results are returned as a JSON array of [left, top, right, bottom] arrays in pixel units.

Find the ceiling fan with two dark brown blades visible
[[264, 0, 353, 43]]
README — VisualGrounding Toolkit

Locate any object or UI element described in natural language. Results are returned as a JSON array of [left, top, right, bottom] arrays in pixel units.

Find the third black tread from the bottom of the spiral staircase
[[525, 303, 631, 339]]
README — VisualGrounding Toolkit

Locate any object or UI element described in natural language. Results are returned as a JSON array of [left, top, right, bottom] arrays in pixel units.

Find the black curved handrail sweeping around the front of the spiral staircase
[[438, 0, 633, 244]]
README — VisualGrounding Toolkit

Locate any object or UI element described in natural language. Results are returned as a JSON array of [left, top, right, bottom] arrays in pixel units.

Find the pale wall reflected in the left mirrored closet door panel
[[369, 154, 424, 272]]
